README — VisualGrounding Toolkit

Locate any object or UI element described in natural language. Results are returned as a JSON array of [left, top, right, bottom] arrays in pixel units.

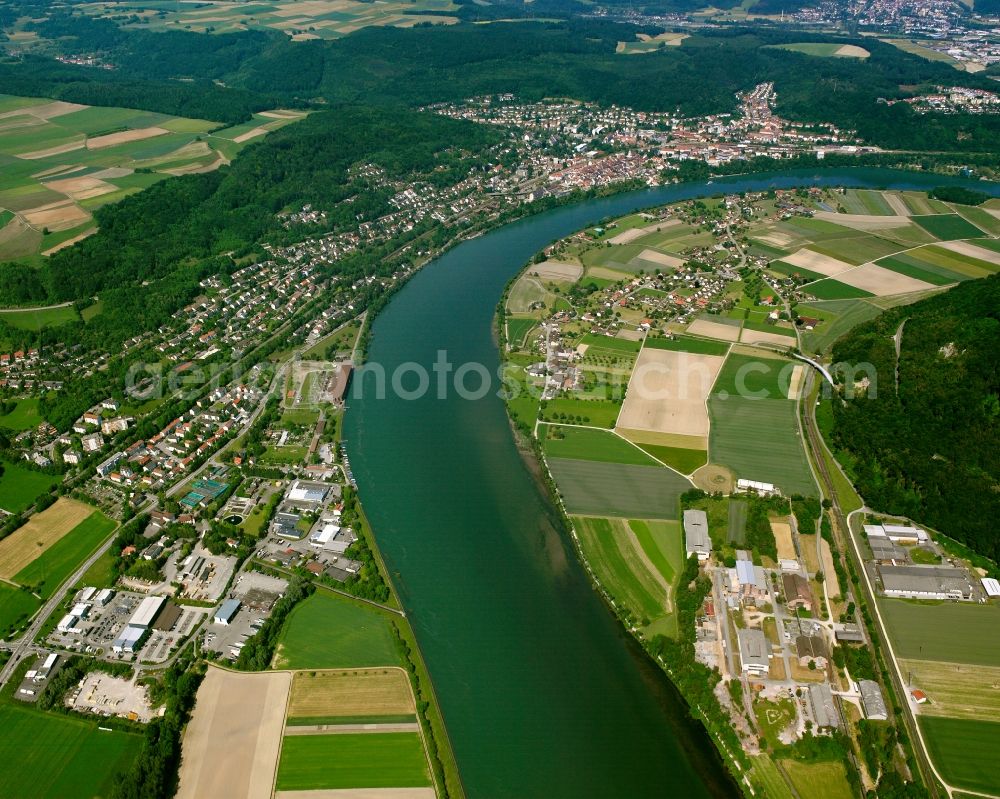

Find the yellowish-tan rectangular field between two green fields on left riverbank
[[288, 668, 416, 724]]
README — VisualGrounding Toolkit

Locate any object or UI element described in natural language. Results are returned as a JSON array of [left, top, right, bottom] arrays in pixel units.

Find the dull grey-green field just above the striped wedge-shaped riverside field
[[548, 458, 691, 519]]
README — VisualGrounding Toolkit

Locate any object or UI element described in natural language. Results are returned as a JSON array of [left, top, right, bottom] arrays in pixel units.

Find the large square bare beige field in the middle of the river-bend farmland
[[618, 348, 726, 447]]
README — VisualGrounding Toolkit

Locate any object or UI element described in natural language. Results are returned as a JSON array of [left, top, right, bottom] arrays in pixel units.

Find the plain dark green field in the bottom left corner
[[0, 701, 142, 799]]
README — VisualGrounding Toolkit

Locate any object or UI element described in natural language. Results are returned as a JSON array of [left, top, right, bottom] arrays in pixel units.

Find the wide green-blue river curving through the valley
[[344, 168, 995, 799]]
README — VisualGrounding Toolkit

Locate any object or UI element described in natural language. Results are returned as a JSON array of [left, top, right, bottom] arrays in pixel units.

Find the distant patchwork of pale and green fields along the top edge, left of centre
[[82, 0, 458, 41]]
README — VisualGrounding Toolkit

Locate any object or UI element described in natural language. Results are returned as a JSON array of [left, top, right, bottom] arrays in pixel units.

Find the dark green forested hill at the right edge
[[834, 275, 1000, 560]]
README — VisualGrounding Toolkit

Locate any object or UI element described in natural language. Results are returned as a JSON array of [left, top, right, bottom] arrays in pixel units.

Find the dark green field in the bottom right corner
[[918, 716, 1000, 794]]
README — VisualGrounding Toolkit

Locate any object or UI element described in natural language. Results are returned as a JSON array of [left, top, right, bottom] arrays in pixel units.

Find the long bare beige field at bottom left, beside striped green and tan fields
[[177, 666, 292, 799]]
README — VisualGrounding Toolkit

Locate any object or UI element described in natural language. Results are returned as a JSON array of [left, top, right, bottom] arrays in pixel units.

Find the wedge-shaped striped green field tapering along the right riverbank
[[573, 517, 680, 627]]
